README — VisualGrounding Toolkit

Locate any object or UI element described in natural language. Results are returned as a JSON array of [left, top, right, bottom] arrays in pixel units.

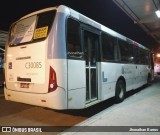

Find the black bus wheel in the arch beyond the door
[[115, 80, 126, 103]]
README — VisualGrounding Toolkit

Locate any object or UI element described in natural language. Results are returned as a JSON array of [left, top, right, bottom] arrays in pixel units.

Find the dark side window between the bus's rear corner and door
[[67, 18, 83, 58]]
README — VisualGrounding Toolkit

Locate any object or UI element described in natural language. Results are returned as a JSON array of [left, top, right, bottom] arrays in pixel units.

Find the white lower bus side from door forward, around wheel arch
[[101, 62, 149, 100]]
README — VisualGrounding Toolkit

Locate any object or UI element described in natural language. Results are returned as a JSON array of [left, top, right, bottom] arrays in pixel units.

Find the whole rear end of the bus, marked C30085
[[5, 7, 67, 109]]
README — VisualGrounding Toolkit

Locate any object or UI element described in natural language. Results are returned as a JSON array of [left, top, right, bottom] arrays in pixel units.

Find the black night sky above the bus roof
[[0, 0, 156, 49]]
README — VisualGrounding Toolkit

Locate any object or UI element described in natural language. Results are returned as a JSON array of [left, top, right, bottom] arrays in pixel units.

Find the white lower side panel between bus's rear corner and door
[[67, 59, 86, 109]]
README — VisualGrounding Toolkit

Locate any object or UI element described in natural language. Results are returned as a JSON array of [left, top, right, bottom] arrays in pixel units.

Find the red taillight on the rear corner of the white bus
[[48, 66, 57, 92]]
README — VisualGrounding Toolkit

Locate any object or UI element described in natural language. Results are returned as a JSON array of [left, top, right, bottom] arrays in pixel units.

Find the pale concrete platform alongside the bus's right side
[[62, 78, 160, 135]]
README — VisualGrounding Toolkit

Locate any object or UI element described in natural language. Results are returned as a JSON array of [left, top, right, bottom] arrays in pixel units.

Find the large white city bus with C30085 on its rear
[[4, 5, 154, 110]]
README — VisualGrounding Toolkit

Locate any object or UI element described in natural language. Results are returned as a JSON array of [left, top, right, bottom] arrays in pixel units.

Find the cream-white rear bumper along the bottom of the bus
[[4, 87, 67, 110]]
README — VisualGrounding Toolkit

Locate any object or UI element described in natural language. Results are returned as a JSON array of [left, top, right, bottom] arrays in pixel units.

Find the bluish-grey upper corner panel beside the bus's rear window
[[47, 12, 68, 59]]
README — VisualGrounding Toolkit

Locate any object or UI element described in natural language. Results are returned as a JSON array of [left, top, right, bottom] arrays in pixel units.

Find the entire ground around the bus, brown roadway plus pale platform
[[0, 78, 160, 135]]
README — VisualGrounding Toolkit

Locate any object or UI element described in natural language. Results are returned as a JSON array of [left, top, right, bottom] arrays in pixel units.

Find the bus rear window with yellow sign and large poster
[[9, 10, 56, 47]]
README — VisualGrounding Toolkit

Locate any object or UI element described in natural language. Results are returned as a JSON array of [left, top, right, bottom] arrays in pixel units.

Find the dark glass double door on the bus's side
[[83, 30, 99, 103]]
